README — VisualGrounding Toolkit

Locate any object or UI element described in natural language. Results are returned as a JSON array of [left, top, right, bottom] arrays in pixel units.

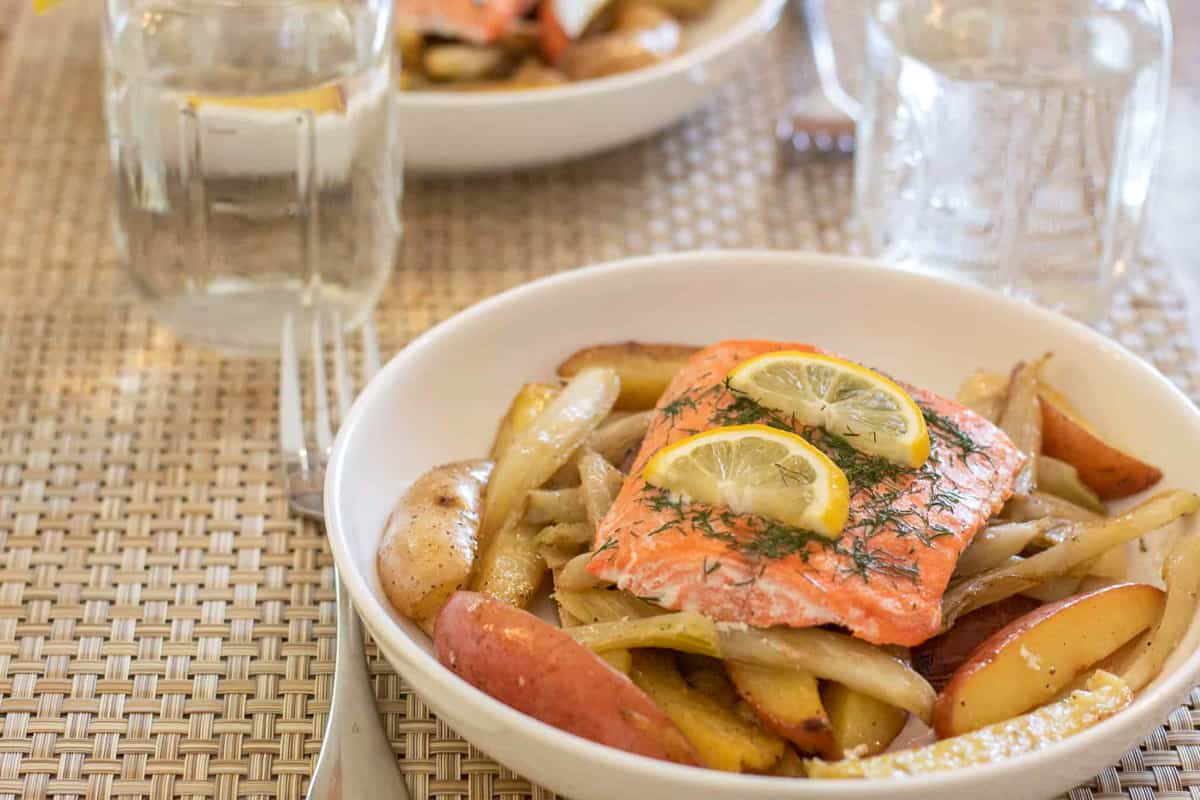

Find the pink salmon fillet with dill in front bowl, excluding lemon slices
[[588, 342, 1025, 646]]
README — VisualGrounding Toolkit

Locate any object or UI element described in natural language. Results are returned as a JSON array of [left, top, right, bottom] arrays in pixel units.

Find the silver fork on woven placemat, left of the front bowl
[[280, 313, 409, 800]]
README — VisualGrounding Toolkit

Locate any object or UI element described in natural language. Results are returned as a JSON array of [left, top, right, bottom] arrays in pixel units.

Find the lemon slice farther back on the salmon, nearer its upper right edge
[[728, 350, 929, 468]]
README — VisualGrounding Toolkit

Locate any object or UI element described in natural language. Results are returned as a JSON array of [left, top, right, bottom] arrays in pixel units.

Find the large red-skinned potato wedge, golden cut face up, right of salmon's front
[[934, 583, 1164, 738]]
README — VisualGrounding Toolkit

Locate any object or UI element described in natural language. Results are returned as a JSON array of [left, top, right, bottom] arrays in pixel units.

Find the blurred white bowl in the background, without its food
[[398, 0, 784, 173]]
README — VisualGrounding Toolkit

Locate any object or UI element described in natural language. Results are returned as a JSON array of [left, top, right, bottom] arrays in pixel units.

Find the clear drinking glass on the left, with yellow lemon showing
[[104, 0, 402, 351]]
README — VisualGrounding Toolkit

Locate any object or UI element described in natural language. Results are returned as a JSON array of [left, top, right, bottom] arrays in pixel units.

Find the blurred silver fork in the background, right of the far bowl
[[776, 0, 859, 163]]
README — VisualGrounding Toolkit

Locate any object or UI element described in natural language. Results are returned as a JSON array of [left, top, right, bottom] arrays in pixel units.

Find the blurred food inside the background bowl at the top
[[396, 0, 714, 91]]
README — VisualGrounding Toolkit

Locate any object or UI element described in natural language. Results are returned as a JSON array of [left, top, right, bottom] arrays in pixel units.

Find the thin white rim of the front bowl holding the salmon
[[324, 249, 1200, 800]]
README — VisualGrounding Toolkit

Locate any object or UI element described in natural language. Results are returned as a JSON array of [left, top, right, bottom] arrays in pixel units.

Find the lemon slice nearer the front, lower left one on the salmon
[[644, 425, 850, 539]]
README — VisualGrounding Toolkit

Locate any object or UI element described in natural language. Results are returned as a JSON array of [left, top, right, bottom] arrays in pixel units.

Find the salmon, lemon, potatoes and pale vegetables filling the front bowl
[[378, 341, 1200, 778]]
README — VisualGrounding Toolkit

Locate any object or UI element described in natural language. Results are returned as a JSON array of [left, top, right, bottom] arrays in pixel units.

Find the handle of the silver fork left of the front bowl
[[307, 567, 408, 800]]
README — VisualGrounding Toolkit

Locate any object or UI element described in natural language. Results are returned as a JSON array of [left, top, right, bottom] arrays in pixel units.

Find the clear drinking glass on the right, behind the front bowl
[[854, 0, 1171, 319]]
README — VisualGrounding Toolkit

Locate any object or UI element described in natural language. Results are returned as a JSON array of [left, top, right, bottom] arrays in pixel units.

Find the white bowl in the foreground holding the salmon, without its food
[[325, 252, 1200, 800]]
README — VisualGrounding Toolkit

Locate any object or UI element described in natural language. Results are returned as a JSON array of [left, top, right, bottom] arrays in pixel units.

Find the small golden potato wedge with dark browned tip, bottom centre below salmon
[[725, 661, 834, 757]]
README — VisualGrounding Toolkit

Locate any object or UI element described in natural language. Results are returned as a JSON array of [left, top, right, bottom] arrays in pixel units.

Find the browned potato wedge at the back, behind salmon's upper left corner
[[558, 342, 700, 410]]
